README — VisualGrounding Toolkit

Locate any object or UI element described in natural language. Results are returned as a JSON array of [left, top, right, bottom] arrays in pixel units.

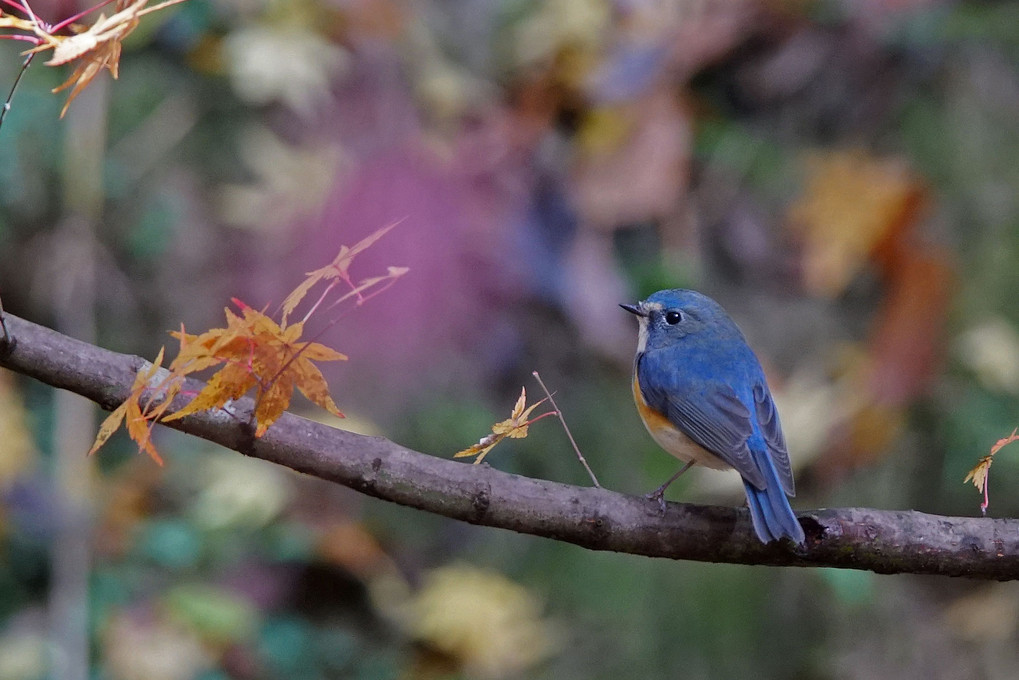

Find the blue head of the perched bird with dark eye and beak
[[620, 289, 743, 353]]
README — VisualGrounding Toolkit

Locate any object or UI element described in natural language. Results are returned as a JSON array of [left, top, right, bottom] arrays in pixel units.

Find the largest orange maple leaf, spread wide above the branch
[[164, 300, 346, 436]]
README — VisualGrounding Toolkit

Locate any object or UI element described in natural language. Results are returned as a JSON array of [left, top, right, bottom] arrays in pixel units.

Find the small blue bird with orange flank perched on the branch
[[620, 289, 804, 543]]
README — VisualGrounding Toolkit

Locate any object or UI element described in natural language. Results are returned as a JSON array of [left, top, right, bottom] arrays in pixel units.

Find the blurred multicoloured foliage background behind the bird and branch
[[0, 0, 1019, 680]]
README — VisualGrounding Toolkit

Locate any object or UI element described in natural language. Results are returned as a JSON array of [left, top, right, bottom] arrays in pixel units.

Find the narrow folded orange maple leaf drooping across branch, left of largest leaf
[[89, 350, 180, 465]]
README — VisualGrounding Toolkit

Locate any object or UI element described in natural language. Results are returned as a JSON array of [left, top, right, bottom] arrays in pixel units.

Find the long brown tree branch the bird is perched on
[[0, 314, 1019, 580]]
